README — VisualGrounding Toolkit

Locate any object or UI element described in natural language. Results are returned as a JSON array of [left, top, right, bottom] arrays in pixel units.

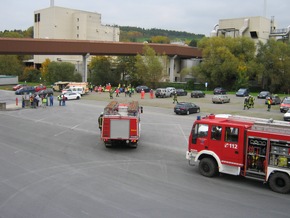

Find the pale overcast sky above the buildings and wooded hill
[[0, 0, 290, 36]]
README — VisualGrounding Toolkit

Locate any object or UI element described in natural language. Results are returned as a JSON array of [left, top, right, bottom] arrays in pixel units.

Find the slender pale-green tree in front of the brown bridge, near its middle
[[135, 45, 166, 88]]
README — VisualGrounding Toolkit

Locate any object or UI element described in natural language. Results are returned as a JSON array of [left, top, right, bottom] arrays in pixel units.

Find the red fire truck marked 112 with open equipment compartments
[[186, 115, 290, 194]]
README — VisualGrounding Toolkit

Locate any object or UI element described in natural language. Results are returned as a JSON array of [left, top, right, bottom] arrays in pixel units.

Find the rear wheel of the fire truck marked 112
[[269, 172, 290, 194]]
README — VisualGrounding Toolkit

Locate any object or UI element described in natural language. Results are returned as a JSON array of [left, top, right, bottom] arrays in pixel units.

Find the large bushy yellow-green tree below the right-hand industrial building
[[196, 37, 256, 90]]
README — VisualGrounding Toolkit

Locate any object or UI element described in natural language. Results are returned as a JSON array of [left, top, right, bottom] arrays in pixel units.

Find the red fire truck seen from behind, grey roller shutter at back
[[101, 101, 143, 148]]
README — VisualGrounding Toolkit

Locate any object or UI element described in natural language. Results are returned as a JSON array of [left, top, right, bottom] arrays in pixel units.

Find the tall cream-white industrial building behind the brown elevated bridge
[[34, 1, 120, 66]]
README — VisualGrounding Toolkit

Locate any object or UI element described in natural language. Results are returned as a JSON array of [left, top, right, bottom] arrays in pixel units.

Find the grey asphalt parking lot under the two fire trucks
[[0, 91, 290, 218]]
